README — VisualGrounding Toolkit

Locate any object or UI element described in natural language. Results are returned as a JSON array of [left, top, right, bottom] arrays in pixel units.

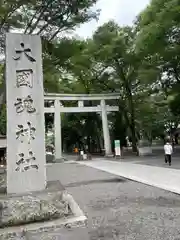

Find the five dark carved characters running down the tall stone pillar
[[13, 43, 38, 172]]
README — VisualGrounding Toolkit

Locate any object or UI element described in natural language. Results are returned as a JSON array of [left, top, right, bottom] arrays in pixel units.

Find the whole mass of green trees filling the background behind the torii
[[0, 0, 180, 154]]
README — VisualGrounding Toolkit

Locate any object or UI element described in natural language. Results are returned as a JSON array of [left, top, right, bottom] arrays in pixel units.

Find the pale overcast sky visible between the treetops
[[76, 0, 150, 37]]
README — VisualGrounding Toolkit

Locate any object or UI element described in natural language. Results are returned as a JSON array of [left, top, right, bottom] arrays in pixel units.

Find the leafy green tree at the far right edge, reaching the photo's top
[[136, 0, 180, 129]]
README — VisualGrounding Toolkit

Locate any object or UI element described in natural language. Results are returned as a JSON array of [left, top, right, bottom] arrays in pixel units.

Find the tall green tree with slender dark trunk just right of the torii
[[88, 22, 152, 151]]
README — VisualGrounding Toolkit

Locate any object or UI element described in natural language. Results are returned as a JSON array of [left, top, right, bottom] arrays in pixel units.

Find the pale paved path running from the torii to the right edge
[[78, 160, 180, 194]]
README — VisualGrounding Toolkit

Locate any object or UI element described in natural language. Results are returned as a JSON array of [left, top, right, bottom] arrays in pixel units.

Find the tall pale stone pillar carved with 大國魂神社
[[6, 33, 46, 194]]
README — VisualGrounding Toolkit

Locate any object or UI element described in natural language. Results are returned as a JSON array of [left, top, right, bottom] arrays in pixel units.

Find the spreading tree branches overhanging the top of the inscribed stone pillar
[[0, 0, 99, 109]]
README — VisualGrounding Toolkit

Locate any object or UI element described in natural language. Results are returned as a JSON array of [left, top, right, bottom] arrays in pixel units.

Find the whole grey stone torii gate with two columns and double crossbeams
[[44, 93, 120, 159]]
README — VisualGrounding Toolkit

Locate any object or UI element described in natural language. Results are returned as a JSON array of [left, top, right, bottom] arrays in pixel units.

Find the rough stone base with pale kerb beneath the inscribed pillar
[[0, 181, 89, 240]]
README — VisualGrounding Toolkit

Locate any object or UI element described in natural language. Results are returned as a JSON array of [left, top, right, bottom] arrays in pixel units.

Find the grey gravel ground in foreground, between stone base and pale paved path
[[47, 163, 180, 240]]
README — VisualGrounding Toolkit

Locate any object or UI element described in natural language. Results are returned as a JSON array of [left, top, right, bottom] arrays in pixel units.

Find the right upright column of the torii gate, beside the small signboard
[[101, 99, 112, 156]]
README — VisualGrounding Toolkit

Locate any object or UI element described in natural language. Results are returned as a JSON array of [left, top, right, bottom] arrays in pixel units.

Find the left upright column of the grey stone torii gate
[[54, 100, 62, 160]]
